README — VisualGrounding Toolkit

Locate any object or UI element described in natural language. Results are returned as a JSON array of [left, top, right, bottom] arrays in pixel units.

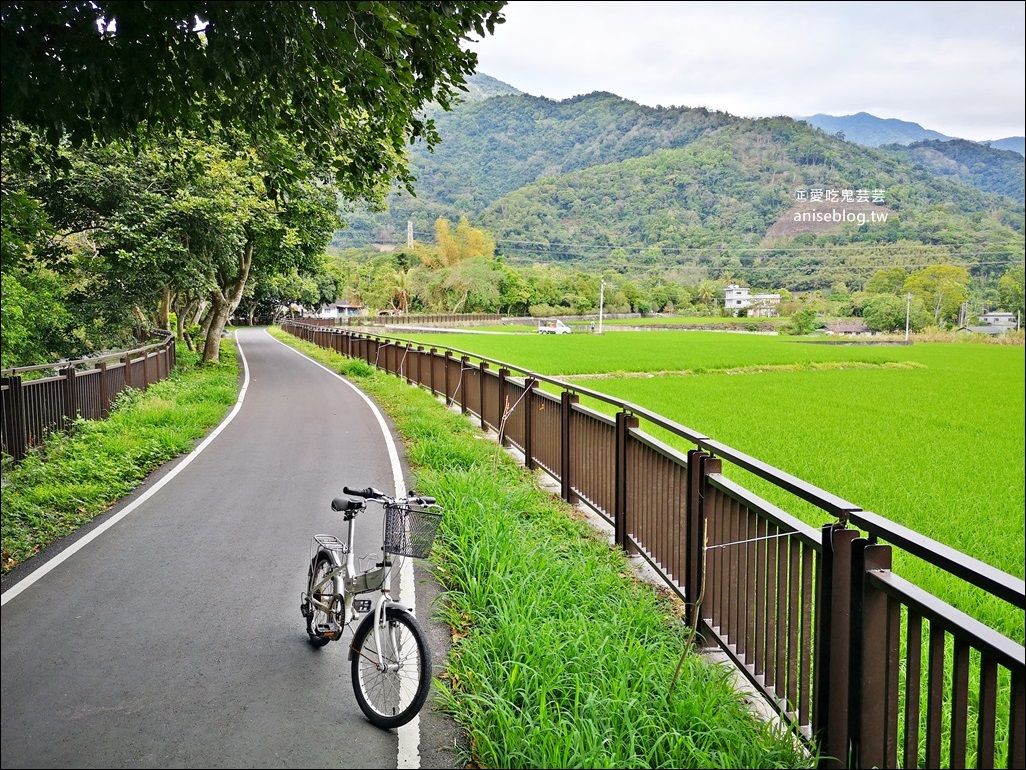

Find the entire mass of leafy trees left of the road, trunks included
[[0, 0, 506, 367]]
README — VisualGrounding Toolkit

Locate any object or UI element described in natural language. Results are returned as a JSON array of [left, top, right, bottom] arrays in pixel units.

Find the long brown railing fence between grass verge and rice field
[[282, 322, 1026, 768]]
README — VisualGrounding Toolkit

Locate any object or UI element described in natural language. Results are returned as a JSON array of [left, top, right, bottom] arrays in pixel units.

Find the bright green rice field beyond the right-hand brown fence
[[385, 332, 1026, 644]]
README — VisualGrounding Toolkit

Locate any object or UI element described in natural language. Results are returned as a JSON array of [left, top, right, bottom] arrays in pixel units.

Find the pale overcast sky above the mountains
[[471, 0, 1026, 141]]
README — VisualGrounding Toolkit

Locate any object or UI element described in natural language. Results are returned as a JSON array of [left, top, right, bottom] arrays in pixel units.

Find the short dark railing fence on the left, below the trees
[[0, 334, 175, 462]]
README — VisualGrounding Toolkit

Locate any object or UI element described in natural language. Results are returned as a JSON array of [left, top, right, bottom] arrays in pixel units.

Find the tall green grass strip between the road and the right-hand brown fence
[[272, 330, 815, 768]]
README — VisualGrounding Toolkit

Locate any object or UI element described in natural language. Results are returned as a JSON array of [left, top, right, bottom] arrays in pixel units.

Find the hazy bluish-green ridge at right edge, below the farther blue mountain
[[880, 139, 1026, 203]]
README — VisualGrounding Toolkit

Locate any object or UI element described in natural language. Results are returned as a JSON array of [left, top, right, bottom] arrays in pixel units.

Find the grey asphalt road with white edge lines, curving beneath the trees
[[0, 329, 459, 769]]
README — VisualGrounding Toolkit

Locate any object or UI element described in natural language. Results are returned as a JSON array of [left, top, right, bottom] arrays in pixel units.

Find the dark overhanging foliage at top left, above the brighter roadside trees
[[0, 0, 506, 198]]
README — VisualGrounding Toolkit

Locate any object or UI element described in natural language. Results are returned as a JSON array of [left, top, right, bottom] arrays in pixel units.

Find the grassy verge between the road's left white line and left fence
[[0, 340, 239, 573]]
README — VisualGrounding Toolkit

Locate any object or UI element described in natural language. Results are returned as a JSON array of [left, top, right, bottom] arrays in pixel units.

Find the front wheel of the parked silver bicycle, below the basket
[[349, 607, 431, 728]]
